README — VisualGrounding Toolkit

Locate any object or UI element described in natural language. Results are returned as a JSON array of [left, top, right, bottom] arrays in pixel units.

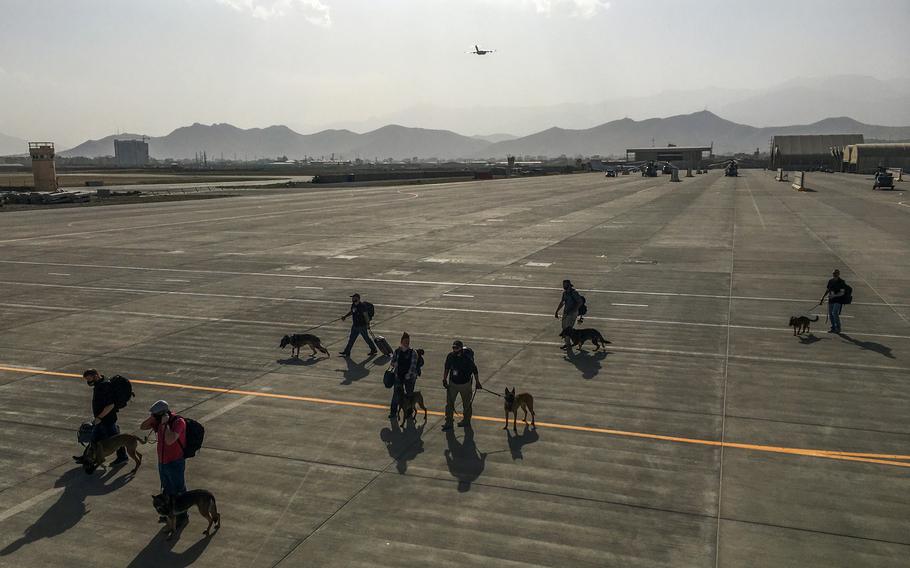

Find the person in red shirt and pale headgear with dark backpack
[[139, 400, 189, 530]]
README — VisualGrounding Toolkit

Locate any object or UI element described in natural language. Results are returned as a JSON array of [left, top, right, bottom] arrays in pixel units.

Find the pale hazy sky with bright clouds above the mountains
[[0, 0, 910, 146]]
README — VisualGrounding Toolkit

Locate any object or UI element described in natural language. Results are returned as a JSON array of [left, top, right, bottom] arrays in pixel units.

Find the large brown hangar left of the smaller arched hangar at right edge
[[770, 134, 863, 171]]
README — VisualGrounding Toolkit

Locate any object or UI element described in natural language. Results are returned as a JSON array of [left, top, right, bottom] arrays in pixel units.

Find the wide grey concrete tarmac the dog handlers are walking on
[[0, 170, 910, 568]]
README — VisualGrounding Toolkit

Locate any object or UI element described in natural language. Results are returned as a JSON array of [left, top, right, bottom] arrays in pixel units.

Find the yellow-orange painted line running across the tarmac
[[0, 366, 910, 468]]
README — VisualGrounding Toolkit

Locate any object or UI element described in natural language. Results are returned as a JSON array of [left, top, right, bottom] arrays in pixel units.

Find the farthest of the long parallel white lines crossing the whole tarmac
[[0, 259, 910, 308]]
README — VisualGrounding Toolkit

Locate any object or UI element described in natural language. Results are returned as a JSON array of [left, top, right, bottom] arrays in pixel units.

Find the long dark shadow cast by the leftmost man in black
[[0, 466, 135, 556]]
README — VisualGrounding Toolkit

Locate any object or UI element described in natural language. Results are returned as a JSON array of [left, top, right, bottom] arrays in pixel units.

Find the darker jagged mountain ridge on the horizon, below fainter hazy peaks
[[60, 111, 910, 160]]
